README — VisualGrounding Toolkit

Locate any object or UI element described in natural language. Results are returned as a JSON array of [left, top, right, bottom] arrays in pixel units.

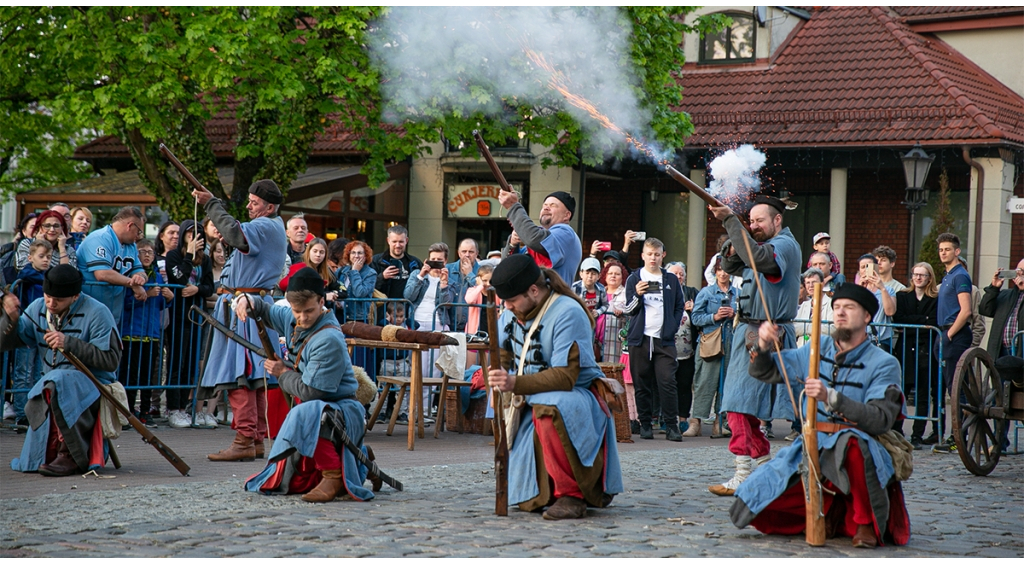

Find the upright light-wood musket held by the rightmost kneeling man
[[803, 283, 825, 547]]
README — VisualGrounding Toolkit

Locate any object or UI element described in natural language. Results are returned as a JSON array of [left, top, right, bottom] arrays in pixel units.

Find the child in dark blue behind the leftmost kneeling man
[[11, 238, 53, 425]]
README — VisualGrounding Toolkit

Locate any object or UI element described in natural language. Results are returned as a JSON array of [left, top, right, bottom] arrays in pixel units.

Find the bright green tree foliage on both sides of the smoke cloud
[[0, 6, 727, 218]]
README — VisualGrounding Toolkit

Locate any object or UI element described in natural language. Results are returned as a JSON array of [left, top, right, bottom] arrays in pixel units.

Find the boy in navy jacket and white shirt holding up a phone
[[625, 237, 686, 441]]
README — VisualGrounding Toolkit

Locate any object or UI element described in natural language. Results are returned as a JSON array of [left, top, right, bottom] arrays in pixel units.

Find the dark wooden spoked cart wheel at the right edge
[[950, 347, 1007, 476]]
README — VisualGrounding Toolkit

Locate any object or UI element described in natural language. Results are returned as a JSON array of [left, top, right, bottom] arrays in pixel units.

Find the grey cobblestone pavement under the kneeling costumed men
[[0, 421, 1024, 558]]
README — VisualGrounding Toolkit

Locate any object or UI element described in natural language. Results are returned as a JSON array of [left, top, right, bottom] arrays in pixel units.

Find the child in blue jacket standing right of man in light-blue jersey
[[118, 238, 172, 427]]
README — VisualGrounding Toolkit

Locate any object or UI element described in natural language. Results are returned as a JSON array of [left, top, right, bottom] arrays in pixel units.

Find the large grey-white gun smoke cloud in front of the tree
[[369, 7, 663, 159]]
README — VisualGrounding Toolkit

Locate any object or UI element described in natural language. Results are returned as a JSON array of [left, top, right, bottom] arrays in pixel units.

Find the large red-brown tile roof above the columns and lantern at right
[[679, 7, 1024, 146]]
